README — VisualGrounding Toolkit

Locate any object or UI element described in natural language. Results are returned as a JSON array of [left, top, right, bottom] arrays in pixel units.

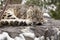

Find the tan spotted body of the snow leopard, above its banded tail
[[2, 6, 44, 24]]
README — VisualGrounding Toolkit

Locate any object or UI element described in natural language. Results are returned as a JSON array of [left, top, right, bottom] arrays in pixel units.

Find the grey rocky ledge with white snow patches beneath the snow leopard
[[0, 19, 60, 40]]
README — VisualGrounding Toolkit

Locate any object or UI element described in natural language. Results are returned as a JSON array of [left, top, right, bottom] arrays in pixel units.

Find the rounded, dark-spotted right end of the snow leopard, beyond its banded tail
[[26, 6, 44, 24]]
